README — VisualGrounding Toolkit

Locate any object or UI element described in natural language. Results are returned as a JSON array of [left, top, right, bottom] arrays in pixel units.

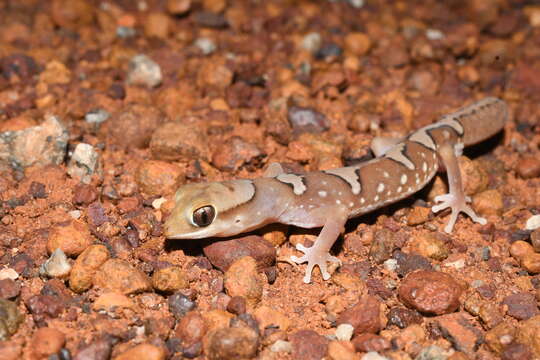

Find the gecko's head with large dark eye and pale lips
[[165, 180, 255, 239]]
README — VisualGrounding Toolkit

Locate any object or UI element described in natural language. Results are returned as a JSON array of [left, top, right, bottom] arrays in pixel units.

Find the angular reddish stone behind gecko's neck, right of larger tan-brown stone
[[212, 136, 266, 172]]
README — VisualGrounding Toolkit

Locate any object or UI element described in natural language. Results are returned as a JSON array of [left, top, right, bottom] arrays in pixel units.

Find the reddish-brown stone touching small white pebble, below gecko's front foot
[[336, 295, 386, 335]]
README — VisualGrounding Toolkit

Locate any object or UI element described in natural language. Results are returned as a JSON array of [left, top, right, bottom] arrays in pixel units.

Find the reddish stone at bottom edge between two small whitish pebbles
[[289, 330, 329, 360]]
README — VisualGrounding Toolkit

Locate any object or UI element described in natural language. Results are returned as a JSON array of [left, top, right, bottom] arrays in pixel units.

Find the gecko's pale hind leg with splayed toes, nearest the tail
[[431, 144, 487, 233]]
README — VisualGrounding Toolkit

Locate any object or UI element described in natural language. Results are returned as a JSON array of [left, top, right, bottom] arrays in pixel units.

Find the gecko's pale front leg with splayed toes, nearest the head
[[291, 207, 347, 284]]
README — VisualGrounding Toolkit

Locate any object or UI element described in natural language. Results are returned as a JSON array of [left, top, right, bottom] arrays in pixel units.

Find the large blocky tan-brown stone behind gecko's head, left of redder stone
[[150, 122, 210, 161]]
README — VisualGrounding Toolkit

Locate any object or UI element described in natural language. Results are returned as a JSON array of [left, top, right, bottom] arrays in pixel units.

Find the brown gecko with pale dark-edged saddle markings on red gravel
[[164, 97, 508, 283]]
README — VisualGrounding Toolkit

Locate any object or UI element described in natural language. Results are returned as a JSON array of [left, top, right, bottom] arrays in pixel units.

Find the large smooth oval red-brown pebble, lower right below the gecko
[[398, 270, 462, 315]]
